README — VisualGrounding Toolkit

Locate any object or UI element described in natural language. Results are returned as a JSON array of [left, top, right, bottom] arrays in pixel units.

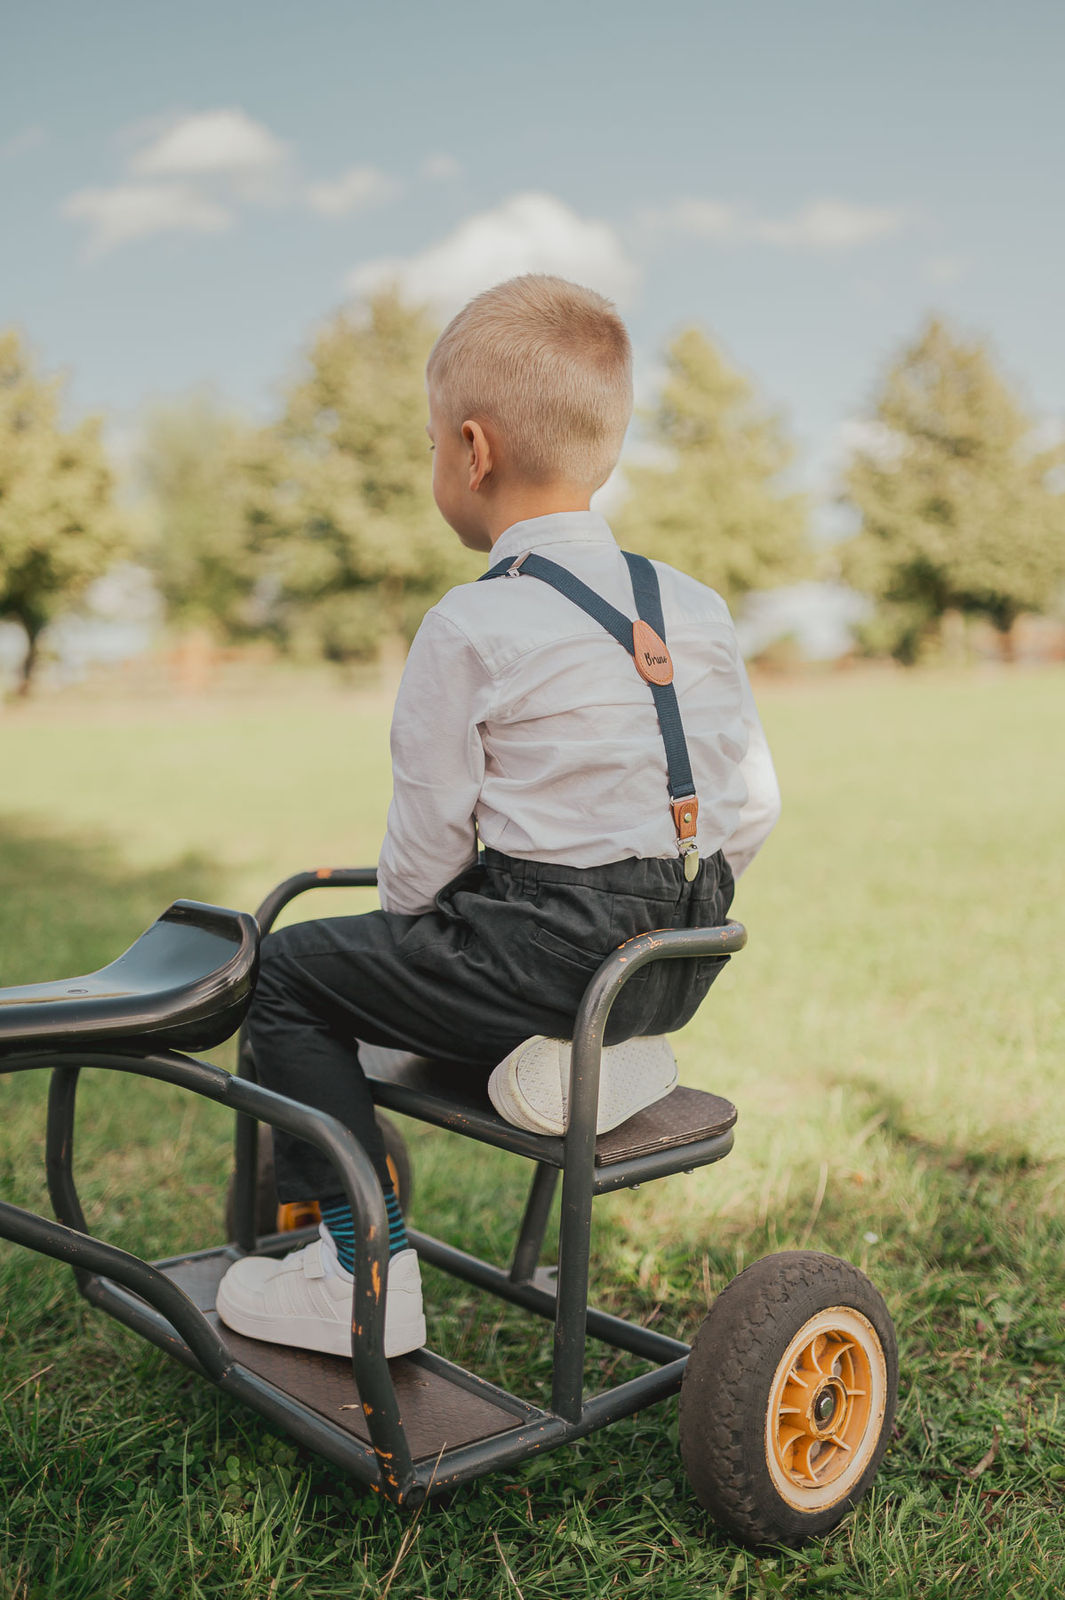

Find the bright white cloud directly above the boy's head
[[345, 194, 640, 312]]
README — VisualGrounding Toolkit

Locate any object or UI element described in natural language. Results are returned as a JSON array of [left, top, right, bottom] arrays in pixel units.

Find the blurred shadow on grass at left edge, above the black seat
[[0, 816, 222, 986]]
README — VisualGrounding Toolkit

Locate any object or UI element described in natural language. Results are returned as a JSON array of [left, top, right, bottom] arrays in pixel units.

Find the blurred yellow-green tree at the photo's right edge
[[841, 320, 1065, 662]]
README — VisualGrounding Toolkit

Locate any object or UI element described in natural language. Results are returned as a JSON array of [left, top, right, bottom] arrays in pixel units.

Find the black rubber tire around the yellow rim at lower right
[[680, 1250, 899, 1547]]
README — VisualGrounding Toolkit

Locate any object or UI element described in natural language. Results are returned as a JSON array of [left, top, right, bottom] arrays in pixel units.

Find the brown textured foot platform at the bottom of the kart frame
[[160, 1250, 530, 1462]]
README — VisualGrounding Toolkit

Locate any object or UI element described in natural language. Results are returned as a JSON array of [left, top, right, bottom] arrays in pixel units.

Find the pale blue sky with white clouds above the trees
[[0, 0, 1065, 491]]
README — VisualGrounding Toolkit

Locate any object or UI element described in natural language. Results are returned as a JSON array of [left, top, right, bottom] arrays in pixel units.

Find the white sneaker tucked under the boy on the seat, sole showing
[[488, 1034, 676, 1134]]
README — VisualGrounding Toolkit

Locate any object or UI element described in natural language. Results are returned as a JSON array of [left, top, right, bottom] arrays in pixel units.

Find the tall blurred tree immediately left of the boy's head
[[245, 291, 480, 662]]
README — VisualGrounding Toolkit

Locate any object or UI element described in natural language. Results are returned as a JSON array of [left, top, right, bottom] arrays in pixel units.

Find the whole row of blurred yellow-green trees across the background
[[0, 293, 1065, 688]]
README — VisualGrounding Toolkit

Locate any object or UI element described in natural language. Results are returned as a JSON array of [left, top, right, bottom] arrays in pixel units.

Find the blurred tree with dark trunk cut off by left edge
[[0, 331, 126, 694]]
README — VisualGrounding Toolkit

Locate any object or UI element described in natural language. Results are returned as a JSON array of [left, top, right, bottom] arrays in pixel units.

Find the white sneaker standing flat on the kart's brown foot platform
[[214, 1222, 425, 1360]]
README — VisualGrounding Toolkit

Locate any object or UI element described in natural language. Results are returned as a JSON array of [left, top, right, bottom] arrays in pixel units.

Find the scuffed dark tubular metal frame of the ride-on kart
[[0, 867, 747, 1506]]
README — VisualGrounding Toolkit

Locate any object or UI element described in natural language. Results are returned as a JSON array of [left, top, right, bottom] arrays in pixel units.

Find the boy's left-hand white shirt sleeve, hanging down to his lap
[[377, 610, 491, 915]]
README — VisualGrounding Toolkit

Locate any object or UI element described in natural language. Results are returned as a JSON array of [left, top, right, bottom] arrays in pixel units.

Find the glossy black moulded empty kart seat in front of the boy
[[0, 901, 259, 1053]]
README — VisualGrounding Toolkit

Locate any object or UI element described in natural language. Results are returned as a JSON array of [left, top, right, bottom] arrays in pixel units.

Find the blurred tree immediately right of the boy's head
[[614, 328, 809, 605]]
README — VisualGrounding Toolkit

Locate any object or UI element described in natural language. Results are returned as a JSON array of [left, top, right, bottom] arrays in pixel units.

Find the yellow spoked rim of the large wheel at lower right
[[766, 1306, 888, 1512]]
